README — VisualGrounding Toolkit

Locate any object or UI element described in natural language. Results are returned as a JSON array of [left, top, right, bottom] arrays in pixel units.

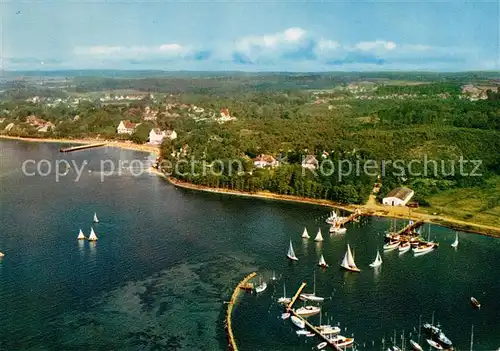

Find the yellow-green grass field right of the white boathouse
[[421, 176, 500, 226]]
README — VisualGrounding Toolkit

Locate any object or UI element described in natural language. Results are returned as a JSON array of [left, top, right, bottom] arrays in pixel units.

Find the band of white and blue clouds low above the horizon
[[14, 27, 492, 71]]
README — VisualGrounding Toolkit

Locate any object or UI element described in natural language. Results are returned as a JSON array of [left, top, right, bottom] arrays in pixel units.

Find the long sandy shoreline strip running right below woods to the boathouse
[[166, 177, 500, 238]]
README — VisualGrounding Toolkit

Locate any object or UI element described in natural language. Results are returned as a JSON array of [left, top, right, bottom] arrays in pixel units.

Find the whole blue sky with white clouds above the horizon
[[0, 0, 500, 72]]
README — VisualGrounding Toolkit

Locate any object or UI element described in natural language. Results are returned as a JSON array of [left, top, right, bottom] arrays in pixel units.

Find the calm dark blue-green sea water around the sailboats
[[0, 141, 500, 350]]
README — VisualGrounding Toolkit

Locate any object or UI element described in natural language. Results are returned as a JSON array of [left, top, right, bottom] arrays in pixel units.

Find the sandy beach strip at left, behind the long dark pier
[[0, 135, 160, 156]]
